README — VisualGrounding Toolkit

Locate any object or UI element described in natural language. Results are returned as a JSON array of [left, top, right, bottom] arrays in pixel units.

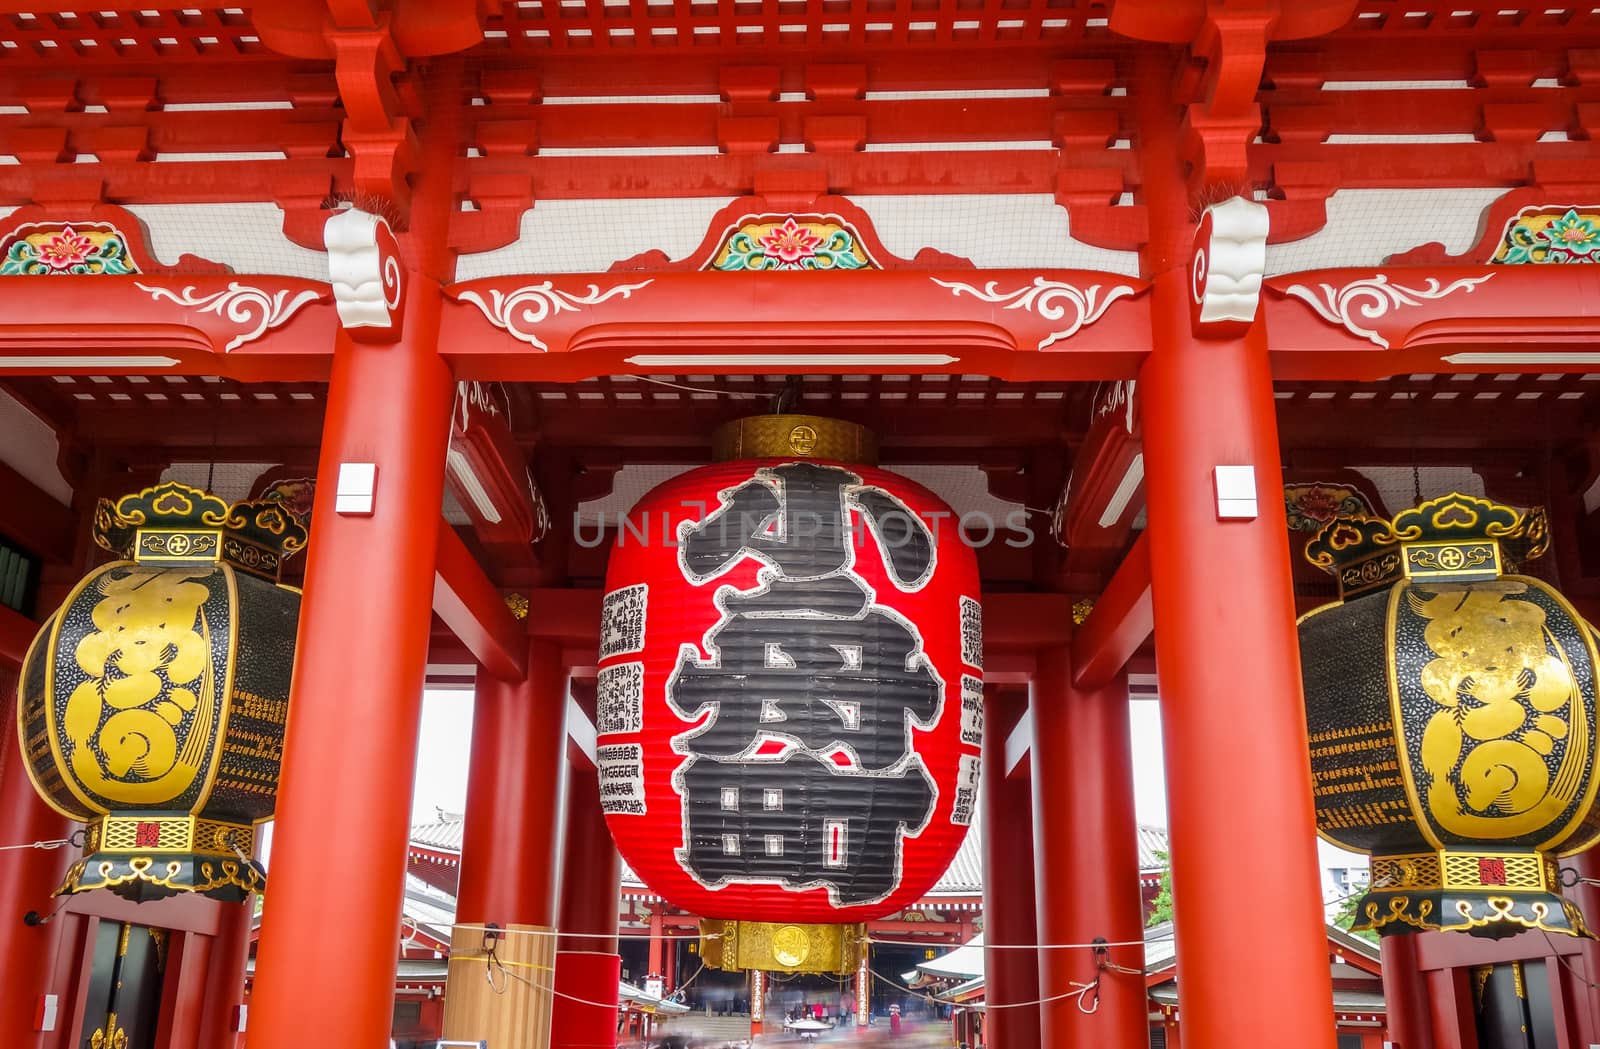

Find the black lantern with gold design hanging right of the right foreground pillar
[[1299, 494, 1600, 937]]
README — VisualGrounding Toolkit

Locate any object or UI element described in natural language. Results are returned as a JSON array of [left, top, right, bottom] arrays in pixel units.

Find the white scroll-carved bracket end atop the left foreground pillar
[[322, 208, 405, 342]]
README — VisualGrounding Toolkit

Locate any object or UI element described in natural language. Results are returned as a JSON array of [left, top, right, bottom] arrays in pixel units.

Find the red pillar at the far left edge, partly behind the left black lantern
[[0, 668, 75, 1047]]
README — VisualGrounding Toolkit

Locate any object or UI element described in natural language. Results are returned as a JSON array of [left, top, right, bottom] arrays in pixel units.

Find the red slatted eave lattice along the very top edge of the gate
[[0, 0, 1600, 67]]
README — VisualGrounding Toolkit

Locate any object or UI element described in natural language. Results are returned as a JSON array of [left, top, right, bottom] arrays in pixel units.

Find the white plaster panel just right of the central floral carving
[[850, 193, 1139, 277]]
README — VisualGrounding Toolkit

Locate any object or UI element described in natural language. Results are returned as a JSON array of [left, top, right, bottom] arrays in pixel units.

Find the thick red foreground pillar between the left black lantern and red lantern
[[250, 303, 454, 1049]]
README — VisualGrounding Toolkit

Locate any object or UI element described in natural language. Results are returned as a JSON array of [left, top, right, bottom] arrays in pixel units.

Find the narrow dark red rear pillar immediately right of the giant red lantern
[[982, 688, 1036, 1049]]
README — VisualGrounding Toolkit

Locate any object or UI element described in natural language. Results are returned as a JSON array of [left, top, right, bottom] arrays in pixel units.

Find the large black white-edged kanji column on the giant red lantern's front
[[667, 462, 944, 905]]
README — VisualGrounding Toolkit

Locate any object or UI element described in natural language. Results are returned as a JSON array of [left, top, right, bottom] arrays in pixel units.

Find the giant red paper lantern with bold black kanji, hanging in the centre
[[597, 416, 982, 963]]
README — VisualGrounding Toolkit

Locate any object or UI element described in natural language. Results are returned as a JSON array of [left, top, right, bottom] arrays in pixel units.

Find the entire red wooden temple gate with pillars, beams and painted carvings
[[0, 0, 1600, 1049]]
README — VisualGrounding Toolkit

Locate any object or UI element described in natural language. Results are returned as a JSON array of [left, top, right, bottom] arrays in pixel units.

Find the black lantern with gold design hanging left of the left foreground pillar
[[18, 483, 306, 900]]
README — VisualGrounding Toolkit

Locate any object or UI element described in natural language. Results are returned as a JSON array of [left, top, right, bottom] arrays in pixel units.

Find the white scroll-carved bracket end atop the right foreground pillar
[[1189, 197, 1270, 336]]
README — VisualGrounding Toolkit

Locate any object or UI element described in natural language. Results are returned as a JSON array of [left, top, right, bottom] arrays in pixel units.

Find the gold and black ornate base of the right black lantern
[[1350, 849, 1592, 939]]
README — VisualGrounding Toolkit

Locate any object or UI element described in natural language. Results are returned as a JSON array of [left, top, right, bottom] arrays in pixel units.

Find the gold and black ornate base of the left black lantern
[[56, 812, 267, 903]]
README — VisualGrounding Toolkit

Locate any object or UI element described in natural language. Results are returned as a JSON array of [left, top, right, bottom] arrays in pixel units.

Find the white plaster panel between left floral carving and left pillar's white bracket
[[128, 203, 328, 281]]
